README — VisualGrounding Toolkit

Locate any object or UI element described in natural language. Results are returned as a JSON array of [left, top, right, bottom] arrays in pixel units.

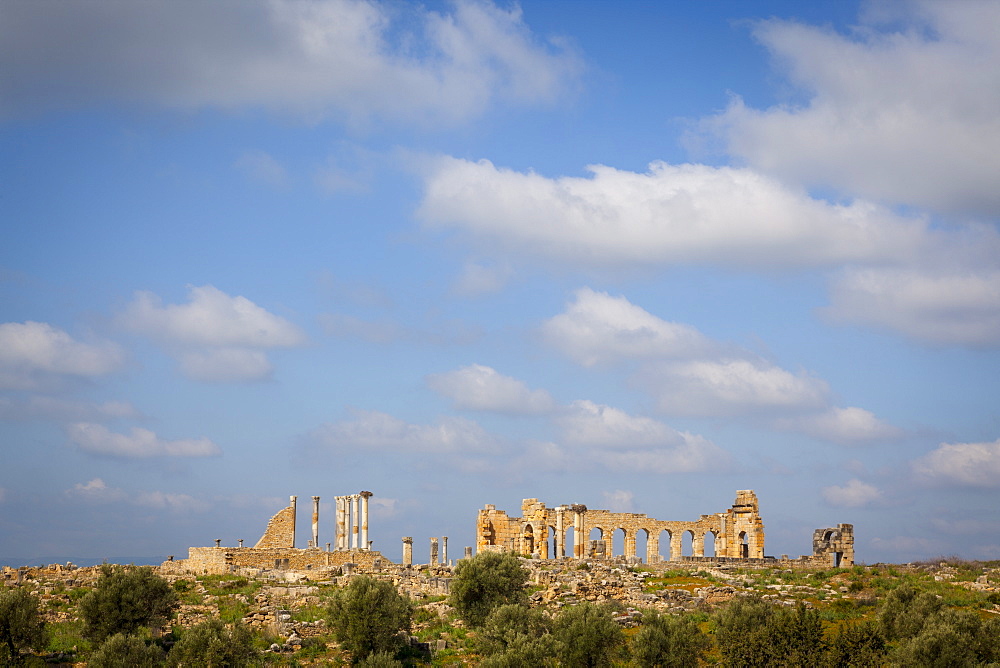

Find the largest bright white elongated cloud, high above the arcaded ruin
[[419, 157, 926, 270]]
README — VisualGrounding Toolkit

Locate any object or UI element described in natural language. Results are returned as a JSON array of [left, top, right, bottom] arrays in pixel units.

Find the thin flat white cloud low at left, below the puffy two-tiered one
[[67, 422, 222, 459]]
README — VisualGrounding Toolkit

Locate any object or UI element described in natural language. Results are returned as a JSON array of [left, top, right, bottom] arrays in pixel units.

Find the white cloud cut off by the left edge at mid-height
[[0, 321, 125, 390]]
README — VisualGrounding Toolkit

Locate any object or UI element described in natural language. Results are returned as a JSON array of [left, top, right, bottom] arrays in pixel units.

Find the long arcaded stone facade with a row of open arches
[[476, 490, 764, 563]]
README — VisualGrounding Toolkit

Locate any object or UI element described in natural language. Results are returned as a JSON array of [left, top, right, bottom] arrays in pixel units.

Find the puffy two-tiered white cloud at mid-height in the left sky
[[118, 285, 306, 381]]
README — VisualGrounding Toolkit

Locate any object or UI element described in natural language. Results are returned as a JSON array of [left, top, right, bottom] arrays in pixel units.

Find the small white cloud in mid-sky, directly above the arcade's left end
[[427, 364, 555, 415]]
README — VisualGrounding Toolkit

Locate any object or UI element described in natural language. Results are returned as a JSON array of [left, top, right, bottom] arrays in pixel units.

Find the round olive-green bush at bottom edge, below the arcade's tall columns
[[552, 603, 625, 668]]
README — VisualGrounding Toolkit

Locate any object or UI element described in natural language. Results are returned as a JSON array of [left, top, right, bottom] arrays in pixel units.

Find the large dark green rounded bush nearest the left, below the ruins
[[80, 564, 178, 642]]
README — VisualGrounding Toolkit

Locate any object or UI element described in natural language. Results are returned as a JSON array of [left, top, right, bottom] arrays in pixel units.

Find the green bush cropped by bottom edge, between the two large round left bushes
[[167, 619, 261, 668]]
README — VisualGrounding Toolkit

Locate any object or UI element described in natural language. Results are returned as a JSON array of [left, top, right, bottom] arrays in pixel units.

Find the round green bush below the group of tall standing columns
[[327, 576, 413, 662]]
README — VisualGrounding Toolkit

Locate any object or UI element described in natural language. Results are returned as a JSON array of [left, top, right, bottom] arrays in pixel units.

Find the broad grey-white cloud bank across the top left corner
[[0, 0, 580, 125]]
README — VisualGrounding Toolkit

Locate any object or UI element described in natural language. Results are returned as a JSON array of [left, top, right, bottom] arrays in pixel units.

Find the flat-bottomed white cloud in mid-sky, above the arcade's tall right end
[[640, 358, 828, 416]]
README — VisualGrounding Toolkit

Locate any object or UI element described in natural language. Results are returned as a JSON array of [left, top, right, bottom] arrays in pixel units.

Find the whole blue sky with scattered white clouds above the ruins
[[0, 0, 1000, 565]]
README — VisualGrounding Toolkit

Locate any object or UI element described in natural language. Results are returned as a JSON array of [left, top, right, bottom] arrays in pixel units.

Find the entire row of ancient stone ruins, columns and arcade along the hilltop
[[163, 490, 854, 573]]
